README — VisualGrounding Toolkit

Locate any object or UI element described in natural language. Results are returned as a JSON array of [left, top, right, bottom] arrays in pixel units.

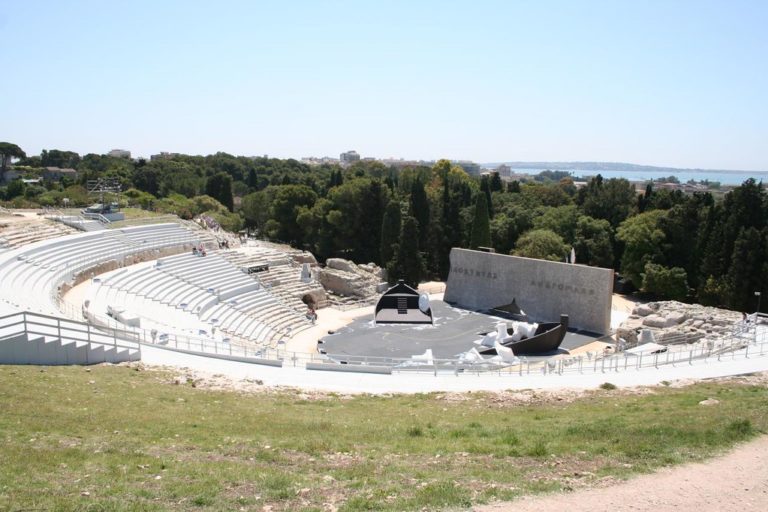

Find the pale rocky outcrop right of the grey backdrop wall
[[616, 301, 742, 347]]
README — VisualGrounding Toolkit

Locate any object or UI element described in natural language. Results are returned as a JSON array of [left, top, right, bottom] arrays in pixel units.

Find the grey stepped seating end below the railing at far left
[[0, 334, 140, 365]]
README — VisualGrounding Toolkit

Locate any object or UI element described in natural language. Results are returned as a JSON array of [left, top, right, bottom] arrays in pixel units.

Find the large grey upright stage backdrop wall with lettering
[[444, 248, 613, 334]]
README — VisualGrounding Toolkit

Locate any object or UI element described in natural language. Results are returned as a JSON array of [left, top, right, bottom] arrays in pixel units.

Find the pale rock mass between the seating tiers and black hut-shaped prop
[[315, 258, 384, 299]]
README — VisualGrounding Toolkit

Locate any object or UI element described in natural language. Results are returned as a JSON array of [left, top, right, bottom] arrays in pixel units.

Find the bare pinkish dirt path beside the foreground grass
[[473, 436, 768, 512]]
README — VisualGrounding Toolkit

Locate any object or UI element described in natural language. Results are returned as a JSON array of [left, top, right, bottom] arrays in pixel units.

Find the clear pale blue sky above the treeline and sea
[[0, 0, 768, 170]]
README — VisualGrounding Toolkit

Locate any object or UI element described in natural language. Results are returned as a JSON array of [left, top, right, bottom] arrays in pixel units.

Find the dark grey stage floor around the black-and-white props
[[318, 300, 601, 359]]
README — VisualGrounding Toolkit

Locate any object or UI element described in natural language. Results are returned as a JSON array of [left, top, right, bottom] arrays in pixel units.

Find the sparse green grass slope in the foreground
[[0, 366, 768, 511]]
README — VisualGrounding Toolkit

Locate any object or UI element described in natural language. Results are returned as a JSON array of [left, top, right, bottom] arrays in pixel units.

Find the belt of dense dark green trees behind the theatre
[[0, 146, 768, 310]]
